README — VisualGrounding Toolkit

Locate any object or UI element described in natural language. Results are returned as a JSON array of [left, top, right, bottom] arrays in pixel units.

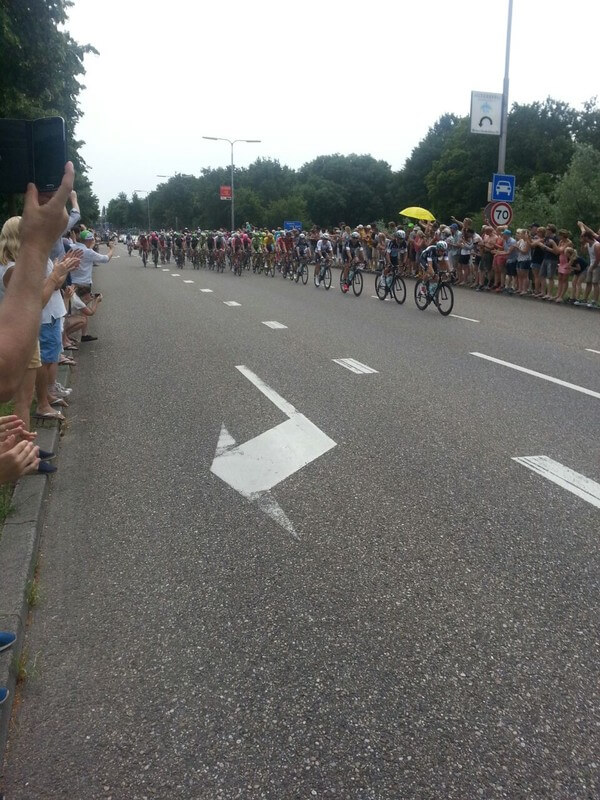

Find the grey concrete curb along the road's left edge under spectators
[[0, 367, 70, 774]]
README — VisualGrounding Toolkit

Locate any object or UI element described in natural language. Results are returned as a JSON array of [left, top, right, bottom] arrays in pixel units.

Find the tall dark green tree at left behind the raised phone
[[0, 0, 98, 221]]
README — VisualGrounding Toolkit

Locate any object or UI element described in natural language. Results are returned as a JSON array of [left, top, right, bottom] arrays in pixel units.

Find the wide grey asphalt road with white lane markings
[[4, 247, 600, 800]]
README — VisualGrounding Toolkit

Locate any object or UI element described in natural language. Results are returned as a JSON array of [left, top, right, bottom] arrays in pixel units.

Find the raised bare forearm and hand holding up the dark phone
[[0, 161, 74, 401]]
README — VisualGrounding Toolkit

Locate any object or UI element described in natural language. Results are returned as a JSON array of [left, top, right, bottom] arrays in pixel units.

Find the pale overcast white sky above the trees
[[68, 0, 600, 204]]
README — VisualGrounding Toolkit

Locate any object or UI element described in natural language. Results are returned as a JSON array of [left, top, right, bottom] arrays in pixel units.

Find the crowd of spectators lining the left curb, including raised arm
[[0, 162, 112, 705]]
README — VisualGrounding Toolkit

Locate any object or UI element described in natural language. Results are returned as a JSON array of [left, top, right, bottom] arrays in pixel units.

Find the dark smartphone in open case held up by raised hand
[[0, 117, 67, 194]]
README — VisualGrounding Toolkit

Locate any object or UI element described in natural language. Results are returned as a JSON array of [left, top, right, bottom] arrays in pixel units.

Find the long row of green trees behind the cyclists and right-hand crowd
[[108, 98, 600, 236]]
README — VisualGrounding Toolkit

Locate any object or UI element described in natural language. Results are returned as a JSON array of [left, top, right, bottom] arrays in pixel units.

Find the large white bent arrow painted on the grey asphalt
[[210, 365, 336, 539]]
